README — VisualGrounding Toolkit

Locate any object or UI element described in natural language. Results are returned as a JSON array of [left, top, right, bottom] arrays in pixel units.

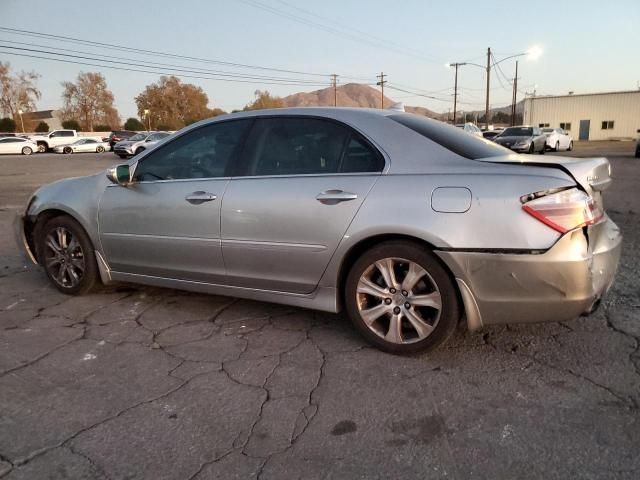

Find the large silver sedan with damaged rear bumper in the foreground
[[16, 108, 622, 353]]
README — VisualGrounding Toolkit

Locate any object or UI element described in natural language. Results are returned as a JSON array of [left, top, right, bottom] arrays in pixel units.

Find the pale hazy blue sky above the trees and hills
[[0, 0, 640, 118]]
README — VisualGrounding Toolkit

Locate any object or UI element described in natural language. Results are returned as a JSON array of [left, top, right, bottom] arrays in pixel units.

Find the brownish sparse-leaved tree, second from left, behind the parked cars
[[62, 72, 120, 131]]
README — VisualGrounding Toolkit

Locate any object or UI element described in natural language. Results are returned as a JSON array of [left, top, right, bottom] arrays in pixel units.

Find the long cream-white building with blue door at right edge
[[522, 90, 640, 140]]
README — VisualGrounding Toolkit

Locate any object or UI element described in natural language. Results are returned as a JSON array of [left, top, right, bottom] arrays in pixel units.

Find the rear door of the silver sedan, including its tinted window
[[222, 116, 384, 293]]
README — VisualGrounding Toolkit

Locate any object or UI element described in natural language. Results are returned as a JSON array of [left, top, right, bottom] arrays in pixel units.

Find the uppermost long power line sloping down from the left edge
[[0, 26, 328, 77]]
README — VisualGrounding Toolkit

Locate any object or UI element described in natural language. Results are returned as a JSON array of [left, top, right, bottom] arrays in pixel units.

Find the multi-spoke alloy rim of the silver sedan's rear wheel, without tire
[[356, 258, 442, 344]]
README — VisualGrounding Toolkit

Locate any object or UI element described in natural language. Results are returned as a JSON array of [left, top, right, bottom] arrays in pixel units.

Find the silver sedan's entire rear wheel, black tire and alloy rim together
[[344, 241, 460, 354]]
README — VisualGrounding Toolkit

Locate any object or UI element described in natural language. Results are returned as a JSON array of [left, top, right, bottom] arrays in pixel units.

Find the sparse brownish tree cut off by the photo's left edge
[[0, 62, 40, 118]]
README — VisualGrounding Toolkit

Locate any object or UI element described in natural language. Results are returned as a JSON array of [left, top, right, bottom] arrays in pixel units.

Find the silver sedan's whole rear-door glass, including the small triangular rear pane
[[246, 117, 384, 176]]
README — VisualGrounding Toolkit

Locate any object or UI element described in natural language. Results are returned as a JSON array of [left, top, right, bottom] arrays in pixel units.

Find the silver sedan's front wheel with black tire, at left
[[34, 215, 98, 295]]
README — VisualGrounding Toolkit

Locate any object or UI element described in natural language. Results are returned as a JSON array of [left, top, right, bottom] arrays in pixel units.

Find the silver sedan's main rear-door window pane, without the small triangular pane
[[247, 117, 351, 176]]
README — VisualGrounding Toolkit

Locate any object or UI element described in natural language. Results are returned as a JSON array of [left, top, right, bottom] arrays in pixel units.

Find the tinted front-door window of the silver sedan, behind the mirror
[[134, 120, 251, 181]]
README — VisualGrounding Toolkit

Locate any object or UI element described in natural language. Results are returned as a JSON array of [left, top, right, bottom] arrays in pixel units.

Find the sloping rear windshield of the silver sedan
[[387, 113, 511, 160]]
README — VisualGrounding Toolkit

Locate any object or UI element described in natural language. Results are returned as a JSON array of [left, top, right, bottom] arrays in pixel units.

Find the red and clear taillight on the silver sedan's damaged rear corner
[[521, 188, 604, 233]]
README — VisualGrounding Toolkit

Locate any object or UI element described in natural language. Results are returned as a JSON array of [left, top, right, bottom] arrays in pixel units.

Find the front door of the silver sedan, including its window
[[98, 120, 250, 283]]
